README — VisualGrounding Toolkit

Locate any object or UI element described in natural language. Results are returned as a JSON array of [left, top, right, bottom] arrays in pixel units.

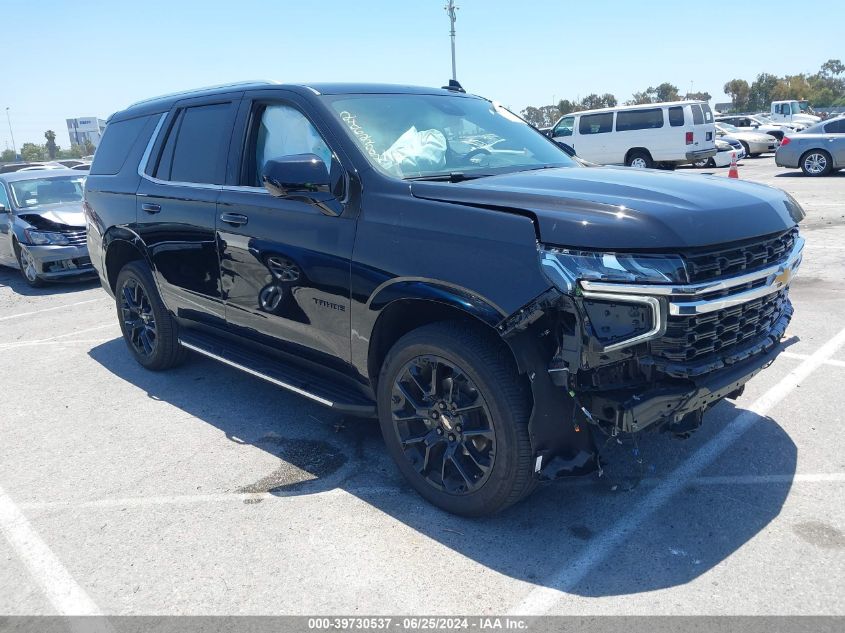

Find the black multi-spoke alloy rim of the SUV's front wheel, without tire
[[392, 356, 496, 495]]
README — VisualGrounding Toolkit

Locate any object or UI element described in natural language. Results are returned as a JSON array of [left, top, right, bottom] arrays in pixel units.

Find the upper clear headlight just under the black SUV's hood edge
[[540, 248, 688, 294]]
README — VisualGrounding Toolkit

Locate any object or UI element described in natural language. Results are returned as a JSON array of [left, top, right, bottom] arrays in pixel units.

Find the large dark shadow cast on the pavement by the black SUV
[[89, 339, 797, 596]]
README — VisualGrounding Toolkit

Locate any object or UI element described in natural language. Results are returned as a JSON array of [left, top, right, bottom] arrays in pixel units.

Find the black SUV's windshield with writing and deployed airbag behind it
[[324, 94, 576, 178]]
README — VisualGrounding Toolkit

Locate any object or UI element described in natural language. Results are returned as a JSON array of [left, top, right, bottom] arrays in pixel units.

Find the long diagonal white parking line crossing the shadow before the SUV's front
[[510, 329, 845, 615]]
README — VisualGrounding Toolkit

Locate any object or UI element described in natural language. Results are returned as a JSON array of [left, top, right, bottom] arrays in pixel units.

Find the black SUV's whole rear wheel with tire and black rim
[[114, 261, 187, 371]]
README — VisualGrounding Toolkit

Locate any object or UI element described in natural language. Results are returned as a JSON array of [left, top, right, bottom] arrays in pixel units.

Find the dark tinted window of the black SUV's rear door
[[155, 103, 231, 184]]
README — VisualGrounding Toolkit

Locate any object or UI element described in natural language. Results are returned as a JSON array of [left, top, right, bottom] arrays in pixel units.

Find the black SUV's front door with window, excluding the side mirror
[[217, 91, 355, 362]]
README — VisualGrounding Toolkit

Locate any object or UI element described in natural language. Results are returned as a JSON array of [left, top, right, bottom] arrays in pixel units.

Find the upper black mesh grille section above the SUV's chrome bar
[[683, 228, 798, 283]]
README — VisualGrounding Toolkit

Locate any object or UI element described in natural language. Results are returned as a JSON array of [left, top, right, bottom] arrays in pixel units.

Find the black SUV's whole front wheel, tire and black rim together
[[378, 322, 536, 516]]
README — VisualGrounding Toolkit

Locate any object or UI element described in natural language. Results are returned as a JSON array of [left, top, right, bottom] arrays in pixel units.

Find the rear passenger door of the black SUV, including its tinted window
[[137, 93, 241, 326]]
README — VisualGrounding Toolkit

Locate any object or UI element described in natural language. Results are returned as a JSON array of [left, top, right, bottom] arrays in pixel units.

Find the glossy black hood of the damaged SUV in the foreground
[[411, 167, 803, 251]]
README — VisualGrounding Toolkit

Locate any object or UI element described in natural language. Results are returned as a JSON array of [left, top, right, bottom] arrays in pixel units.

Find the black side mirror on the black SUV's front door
[[261, 154, 343, 215]]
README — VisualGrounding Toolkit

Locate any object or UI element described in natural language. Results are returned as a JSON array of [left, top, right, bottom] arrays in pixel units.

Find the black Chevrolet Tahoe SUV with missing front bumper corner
[[85, 83, 804, 515]]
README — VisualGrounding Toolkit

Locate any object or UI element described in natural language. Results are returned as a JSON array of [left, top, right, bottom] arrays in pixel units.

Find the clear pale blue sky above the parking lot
[[0, 0, 845, 150]]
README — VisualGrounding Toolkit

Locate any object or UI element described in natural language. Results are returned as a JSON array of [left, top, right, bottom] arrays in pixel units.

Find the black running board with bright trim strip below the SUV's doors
[[179, 332, 376, 417]]
